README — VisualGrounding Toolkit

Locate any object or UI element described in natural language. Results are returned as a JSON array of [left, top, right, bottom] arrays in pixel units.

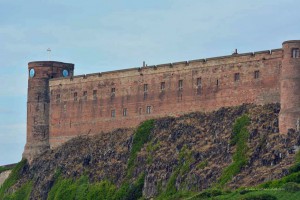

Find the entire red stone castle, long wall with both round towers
[[23, 40, 300, 161]]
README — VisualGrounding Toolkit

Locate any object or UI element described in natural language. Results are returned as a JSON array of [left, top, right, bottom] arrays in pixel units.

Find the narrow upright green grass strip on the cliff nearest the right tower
[[218, 115, 250, 188]]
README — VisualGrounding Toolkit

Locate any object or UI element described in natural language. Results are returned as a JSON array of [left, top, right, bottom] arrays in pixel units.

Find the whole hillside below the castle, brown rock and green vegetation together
[[0, 104, 300, 199]]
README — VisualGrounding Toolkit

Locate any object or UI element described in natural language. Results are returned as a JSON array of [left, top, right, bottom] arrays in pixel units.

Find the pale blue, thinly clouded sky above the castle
[[0, 0, 300, 165]]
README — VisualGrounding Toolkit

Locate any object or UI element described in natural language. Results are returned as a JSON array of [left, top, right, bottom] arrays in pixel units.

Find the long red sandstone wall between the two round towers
[[49, 49, 282, 147]]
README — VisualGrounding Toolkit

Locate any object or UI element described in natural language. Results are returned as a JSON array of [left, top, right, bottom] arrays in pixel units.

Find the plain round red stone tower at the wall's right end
[[279, 40, 300, 133]]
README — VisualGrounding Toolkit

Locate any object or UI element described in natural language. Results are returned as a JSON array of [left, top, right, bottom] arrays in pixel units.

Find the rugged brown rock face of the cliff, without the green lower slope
[[1, 104, 300, 199]]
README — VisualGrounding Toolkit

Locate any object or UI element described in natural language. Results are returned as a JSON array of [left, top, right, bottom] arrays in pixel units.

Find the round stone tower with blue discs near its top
[[23, 61, 74, 163]]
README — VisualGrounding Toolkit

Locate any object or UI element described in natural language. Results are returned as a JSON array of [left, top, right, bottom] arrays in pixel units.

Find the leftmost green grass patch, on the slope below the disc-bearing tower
[[0, 160, 32, 199]]
